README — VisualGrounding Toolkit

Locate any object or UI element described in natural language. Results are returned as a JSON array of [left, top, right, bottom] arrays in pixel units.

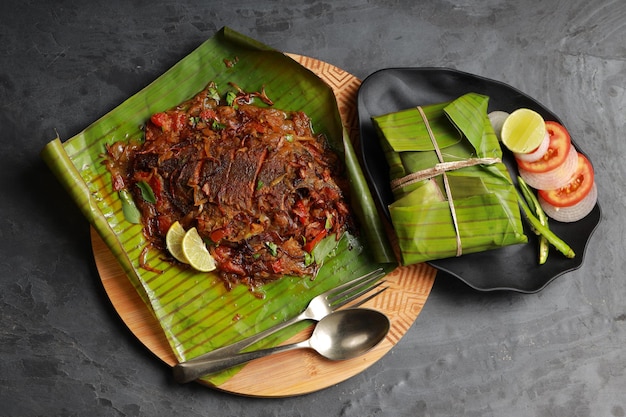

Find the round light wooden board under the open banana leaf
[[91, 54, 436, 397]]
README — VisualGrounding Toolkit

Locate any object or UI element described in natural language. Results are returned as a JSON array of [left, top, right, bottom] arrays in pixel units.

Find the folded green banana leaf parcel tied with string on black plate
[[372, 93, 527, 265]]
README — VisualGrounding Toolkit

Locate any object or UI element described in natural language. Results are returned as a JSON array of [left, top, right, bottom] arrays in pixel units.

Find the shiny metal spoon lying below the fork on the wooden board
[[174, 308, 390, 383]]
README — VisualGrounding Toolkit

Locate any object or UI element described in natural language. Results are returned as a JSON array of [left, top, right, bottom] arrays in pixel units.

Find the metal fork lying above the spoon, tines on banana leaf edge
[[174, 268, 387, 363]]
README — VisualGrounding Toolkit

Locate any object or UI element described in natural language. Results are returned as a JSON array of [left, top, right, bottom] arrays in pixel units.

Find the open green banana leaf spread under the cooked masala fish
[[42, 28, 395, 385]]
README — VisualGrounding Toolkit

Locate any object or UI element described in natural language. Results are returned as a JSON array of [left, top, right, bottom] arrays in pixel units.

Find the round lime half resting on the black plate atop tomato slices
[[501, 108, 546, 153]]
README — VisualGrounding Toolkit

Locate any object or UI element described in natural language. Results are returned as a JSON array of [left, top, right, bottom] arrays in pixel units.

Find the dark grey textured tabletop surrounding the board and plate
[[0, 0, 626, 417]]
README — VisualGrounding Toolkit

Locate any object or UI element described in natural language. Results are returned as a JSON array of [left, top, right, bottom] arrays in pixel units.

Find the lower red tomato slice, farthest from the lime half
[[538, 153, 594, 207]]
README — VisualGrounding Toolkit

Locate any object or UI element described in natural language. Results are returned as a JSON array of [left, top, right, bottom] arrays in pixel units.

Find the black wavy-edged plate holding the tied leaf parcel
[[358, 68, 600, 293]]
